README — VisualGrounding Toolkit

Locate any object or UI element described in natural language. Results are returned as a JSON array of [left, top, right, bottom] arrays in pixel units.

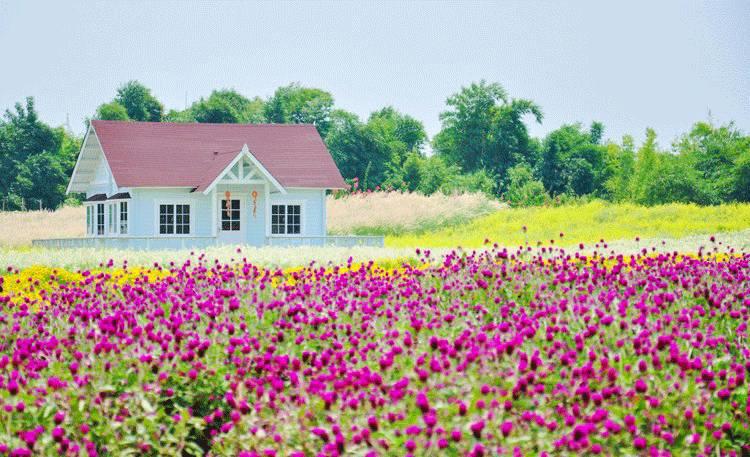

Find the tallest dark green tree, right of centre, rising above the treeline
[[433, 81, 542, 191]]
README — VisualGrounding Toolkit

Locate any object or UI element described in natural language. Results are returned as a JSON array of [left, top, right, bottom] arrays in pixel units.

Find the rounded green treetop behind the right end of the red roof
[[264, 83, 333, 138]]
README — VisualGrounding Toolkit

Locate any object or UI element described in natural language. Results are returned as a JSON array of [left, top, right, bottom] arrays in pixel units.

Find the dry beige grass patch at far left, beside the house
[[0, 206, 86, 247]]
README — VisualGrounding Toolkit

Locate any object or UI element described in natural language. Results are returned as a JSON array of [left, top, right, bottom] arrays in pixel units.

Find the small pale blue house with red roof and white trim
[[36, 121, 382, 249]]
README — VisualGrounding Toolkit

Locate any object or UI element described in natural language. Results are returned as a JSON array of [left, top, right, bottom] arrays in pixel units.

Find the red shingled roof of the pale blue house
[[91, 121, 346, 189]]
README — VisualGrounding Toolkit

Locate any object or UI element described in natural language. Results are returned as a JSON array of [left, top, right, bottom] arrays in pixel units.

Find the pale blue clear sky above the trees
[[0, 0, 750, 145]]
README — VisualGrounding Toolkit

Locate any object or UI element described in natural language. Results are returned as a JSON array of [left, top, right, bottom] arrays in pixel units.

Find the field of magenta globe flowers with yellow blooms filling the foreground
[[0, 243, 750, 457]]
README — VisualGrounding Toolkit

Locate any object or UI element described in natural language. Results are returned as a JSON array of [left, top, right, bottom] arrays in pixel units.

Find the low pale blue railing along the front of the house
[[31, 235, 385, 250]]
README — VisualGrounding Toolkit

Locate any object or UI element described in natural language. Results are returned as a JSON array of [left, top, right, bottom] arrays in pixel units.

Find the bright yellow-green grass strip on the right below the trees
[[386, 201, 750, 247]]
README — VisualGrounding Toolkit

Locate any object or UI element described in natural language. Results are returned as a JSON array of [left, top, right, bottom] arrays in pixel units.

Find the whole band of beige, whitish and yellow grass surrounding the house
[[0, 197, 750, 268]]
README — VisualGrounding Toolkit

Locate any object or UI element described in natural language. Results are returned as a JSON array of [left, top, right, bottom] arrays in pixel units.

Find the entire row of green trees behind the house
[[0, 81, 750, 208]]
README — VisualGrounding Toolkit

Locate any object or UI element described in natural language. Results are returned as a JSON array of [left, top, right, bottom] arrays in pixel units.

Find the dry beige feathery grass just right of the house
[[327, 192, 501, 235]]
